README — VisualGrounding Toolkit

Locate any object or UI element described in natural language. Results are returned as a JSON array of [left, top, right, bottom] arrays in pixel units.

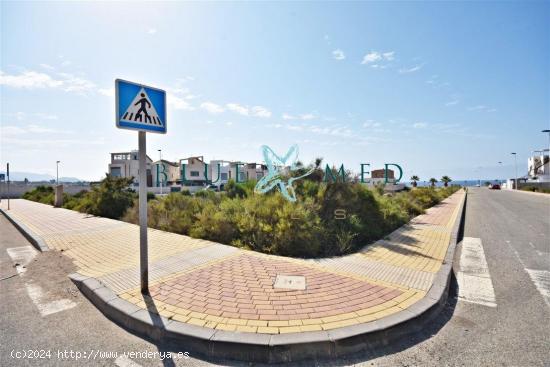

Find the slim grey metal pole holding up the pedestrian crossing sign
[[138, 131, 149, 294]]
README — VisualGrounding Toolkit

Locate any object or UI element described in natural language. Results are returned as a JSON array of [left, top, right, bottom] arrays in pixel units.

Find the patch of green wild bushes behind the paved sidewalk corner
[[20, 172, 460, 258]]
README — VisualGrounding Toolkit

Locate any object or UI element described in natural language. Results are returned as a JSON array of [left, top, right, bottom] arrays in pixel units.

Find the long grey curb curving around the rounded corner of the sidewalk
[[68, 192, 467, 363]]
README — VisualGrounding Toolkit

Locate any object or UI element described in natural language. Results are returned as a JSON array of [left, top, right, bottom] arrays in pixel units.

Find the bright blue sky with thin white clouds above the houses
[[0, 1, 550, 180]]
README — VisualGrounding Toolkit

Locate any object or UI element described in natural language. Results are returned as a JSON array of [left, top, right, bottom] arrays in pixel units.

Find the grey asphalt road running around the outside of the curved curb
[[0, 188, 550, 367]]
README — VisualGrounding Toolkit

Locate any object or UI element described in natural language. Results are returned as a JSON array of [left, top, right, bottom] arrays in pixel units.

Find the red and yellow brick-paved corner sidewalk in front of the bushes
[[1, 190, 465, 334]]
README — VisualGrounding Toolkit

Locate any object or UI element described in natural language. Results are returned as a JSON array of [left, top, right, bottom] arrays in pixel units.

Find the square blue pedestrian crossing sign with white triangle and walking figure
[[115, 79, 166, 134]]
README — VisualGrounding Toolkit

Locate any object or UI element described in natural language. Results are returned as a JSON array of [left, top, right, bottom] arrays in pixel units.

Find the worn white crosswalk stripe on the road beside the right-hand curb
[[456, 237, 497, 307]]
